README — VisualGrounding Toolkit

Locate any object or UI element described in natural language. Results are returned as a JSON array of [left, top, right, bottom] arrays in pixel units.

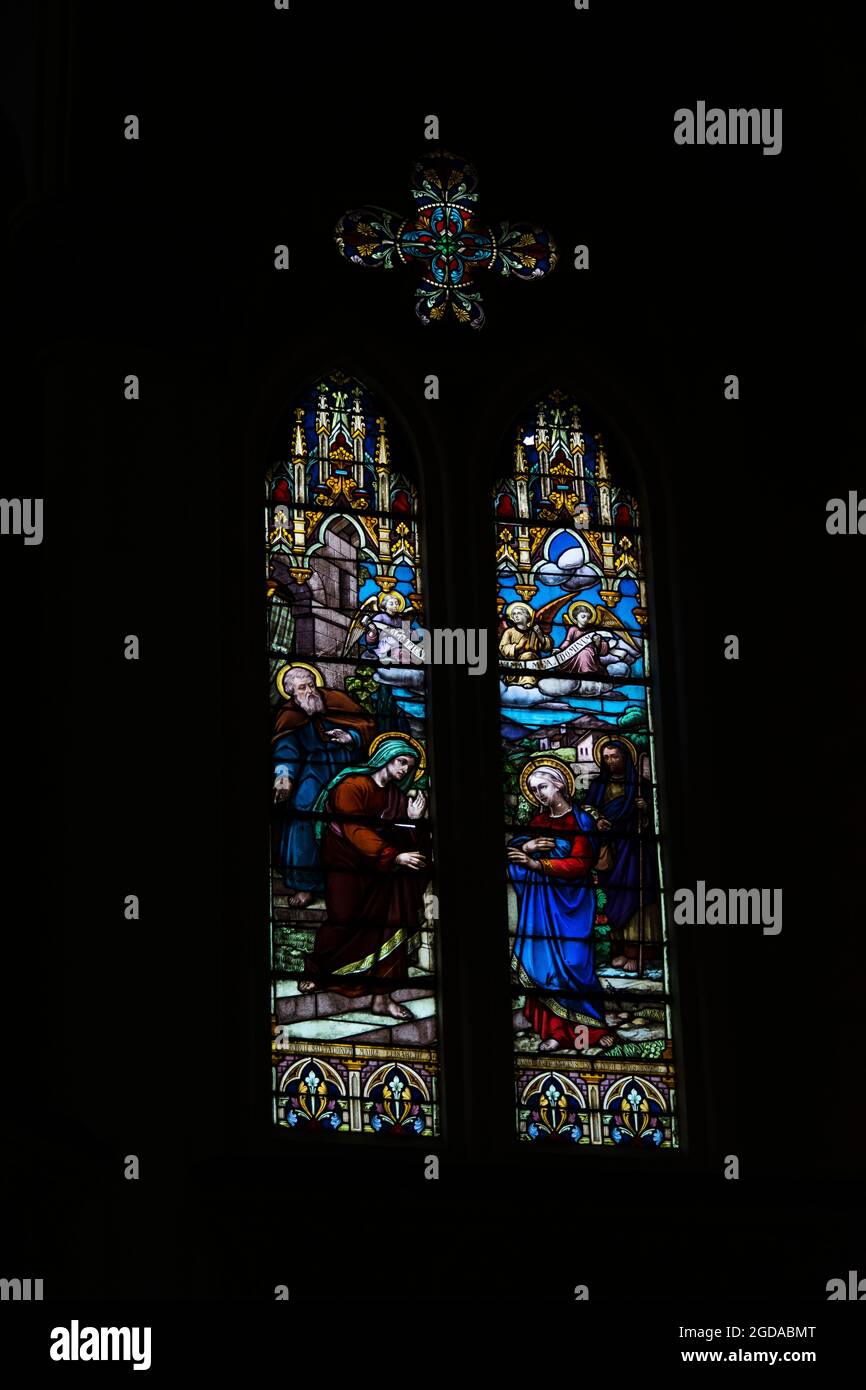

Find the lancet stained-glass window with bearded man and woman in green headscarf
[[263, 373, 439, 1143]]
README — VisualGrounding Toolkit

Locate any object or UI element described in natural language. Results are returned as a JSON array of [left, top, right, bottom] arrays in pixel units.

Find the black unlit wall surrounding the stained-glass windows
[[0, 0, 866, 1351]]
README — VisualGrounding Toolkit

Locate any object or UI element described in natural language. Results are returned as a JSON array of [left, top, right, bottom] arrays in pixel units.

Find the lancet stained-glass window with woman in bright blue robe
[[495, 391, 678, 1150]]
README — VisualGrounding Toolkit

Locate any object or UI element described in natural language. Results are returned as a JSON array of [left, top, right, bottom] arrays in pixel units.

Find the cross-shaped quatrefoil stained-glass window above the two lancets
[[334, 150, 556, 328]]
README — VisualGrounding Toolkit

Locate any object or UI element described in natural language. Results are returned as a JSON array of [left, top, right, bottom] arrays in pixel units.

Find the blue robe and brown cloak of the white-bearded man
[[274, 687, 375, 892]]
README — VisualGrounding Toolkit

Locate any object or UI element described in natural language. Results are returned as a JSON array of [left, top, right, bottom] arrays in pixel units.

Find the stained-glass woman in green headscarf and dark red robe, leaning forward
[[299, 734, 430, 1019]]
